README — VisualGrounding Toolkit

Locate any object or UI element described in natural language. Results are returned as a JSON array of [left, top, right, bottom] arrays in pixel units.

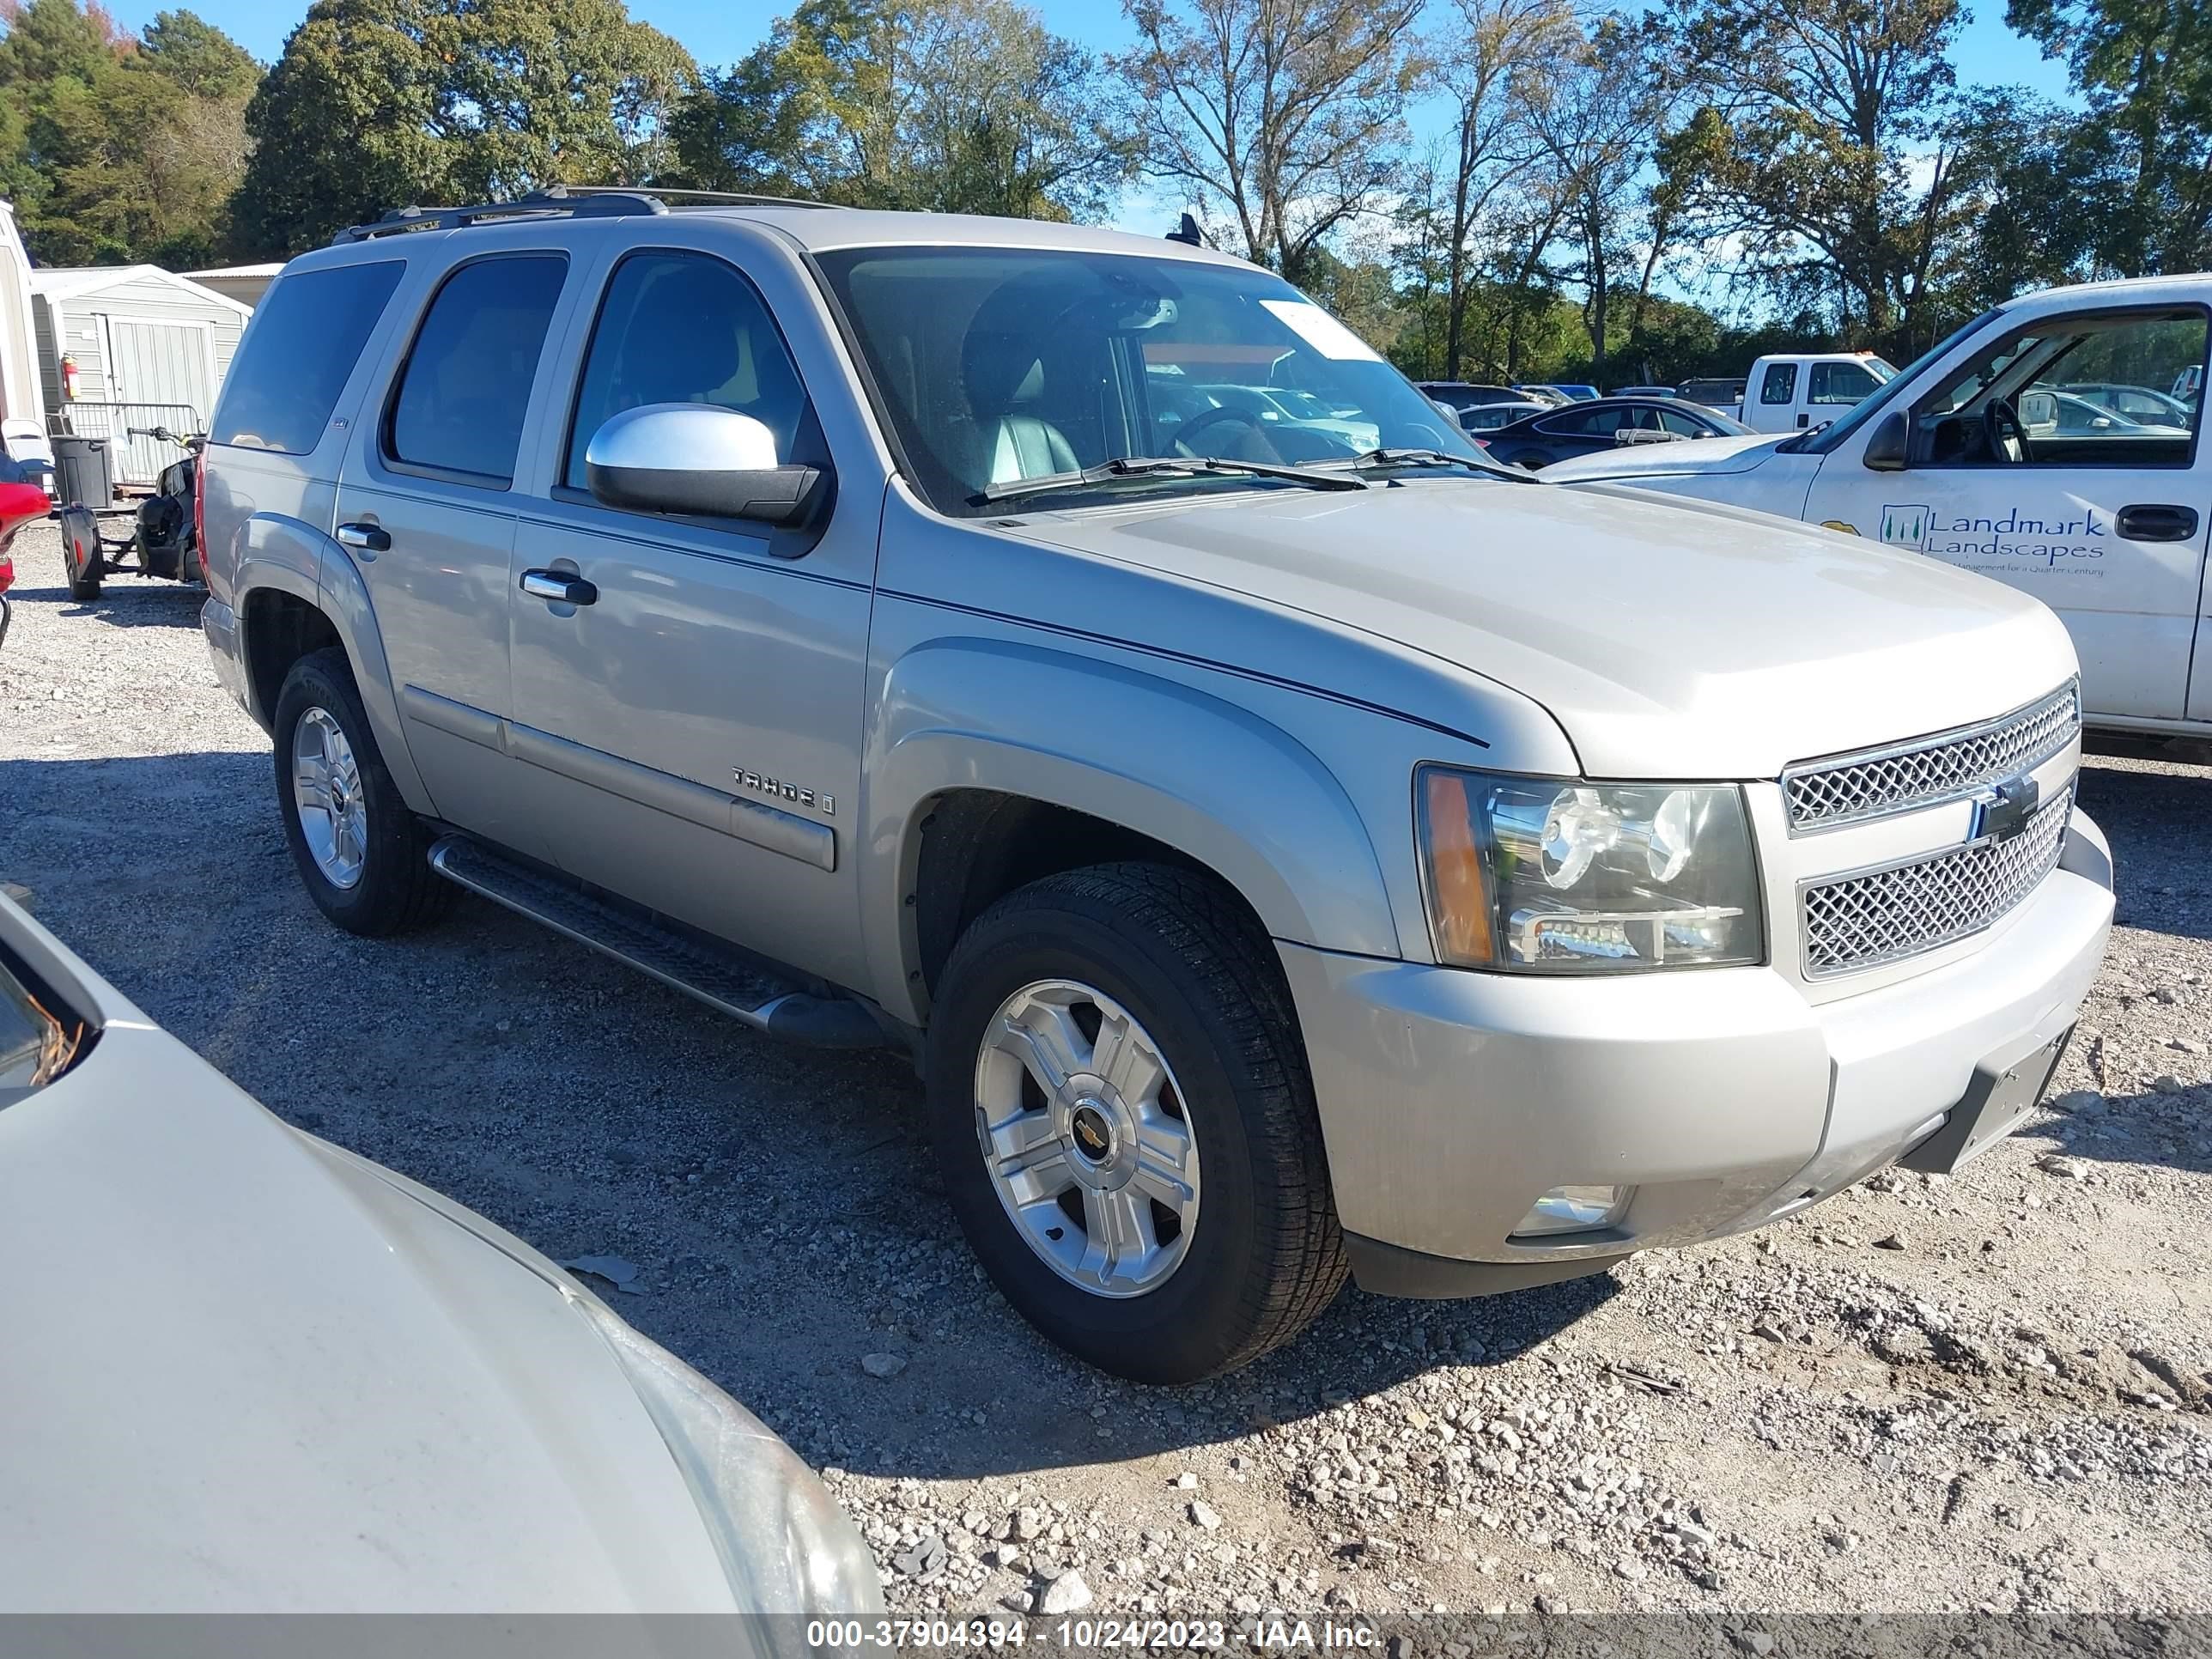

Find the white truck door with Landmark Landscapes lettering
[[1805, 307, 2212, 719]]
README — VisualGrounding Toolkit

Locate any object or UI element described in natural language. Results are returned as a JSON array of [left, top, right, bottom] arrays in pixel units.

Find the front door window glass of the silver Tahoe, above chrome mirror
[[562, 252, 823, 489]]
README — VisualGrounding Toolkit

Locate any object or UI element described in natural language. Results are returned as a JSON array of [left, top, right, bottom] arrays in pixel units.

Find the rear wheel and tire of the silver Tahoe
[[274, 646, 453, 938]]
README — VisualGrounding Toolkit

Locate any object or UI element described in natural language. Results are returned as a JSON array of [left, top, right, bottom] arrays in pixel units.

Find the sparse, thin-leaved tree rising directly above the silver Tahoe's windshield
[[1110, 0, 1422, 281]]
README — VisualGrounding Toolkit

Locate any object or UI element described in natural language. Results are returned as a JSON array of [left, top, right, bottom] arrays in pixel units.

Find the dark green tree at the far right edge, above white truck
[[2004, 0, 2212, 276]]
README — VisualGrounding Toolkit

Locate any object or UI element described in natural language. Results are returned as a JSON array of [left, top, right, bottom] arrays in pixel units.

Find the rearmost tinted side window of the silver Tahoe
[[208, 258, 407, 456]]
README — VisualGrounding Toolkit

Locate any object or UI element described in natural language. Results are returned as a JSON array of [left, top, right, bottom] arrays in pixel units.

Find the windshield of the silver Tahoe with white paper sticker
[[821, 248, 1475, 515]]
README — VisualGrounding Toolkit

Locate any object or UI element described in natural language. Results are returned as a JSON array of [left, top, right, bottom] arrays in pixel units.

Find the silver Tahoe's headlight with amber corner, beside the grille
[[1413, 765, 1765, 973]]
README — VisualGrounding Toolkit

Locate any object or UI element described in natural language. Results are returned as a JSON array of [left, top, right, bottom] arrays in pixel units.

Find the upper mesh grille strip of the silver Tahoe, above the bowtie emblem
[[1783, 686, 2081, 834]]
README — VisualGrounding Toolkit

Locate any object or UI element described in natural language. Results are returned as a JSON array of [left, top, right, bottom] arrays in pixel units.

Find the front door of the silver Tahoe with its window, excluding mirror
[[507, 248, 883, 984]]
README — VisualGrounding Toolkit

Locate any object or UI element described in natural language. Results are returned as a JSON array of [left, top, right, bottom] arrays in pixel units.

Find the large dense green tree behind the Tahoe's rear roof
[[232, 0, 696, 257]]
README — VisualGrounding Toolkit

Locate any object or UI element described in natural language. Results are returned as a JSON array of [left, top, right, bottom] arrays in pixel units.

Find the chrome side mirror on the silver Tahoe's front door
[[584, 403, 827, 525]]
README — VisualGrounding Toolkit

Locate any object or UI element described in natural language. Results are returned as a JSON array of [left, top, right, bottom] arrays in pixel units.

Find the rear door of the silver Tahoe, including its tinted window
[[337, 256, 568, 871]]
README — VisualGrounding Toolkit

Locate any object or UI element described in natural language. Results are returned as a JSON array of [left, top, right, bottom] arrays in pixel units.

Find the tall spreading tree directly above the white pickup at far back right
[[1656, 0, 1962, 343]]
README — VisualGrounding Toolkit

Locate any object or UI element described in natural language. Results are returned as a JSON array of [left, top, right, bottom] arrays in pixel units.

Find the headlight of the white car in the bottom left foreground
[[573, 1298, 883, 1627]]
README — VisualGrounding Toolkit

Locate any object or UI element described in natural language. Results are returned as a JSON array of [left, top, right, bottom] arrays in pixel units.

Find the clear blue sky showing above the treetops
[[147, 0, 2066, 97]]
